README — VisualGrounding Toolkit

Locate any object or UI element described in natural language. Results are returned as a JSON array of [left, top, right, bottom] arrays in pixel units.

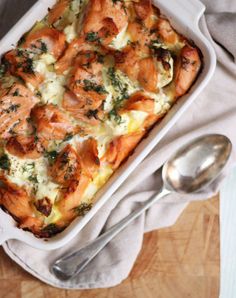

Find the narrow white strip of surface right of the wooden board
[[220, 168, 236, 298]]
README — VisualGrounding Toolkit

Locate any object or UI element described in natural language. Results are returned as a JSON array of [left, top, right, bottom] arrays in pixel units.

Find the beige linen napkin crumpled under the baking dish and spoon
[[3, 0, 236, 289]]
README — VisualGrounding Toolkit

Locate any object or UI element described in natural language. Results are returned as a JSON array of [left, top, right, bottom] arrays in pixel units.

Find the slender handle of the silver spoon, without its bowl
[[52, 188, 170, 280]]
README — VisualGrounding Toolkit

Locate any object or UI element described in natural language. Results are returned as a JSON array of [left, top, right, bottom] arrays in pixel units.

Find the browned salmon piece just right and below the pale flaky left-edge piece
[[32, 104, 78, 147]]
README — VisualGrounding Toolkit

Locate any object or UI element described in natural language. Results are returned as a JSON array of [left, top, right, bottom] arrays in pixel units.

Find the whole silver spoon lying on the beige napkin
[[51, 134, 232, 280]]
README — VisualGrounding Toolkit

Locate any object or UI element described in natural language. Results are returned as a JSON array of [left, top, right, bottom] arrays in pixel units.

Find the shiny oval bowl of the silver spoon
[[162, 134, 232, 193]]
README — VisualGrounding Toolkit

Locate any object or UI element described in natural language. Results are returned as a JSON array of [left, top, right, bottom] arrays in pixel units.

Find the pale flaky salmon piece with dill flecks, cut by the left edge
[[0, 84, 39, 139]]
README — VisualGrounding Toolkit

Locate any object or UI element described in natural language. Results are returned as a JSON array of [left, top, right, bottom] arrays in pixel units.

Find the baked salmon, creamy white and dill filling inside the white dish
[[0, 0, 202, 238]]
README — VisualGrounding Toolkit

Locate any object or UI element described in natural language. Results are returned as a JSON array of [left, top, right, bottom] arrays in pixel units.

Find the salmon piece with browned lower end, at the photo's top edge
[[83, 0, 128, 44]]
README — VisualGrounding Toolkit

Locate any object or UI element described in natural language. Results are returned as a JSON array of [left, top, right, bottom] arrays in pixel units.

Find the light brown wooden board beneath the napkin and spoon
[[0, 197, 219, 298]]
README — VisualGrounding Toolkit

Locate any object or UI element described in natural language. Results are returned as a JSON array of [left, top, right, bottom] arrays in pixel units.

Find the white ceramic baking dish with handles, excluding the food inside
[[0, 0, 216, 250]]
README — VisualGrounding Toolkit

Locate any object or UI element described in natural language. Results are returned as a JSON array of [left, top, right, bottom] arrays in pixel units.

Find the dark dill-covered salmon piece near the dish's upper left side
[[4, 50, 44, 88]]
